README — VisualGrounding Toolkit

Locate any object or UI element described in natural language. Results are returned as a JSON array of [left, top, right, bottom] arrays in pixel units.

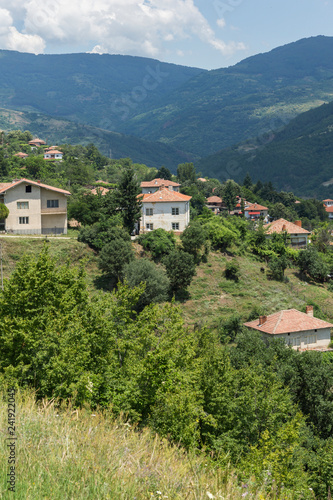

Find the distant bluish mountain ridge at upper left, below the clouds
[[0, 50, 204, 131]]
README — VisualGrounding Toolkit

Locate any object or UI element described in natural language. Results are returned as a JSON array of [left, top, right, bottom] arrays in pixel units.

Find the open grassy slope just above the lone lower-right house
[[182, 253, 333, 327]]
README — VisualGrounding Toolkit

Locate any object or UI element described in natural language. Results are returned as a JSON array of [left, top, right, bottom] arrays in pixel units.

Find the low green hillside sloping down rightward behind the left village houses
[[0, 108, 194, 171]]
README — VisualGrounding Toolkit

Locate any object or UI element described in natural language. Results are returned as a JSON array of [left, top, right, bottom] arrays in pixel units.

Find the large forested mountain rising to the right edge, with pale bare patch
[[121, 36, 333, 156]]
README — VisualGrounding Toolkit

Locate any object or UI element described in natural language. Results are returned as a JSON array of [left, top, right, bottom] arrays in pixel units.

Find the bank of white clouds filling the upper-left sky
[[0, 0, 244, 58]]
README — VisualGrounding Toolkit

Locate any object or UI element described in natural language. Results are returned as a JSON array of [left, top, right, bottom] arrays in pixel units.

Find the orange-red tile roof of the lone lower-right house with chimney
[[244, 309, 333, 335]]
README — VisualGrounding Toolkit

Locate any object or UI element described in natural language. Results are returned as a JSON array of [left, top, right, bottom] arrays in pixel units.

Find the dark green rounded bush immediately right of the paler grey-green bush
[[163, 250, 196, 292]]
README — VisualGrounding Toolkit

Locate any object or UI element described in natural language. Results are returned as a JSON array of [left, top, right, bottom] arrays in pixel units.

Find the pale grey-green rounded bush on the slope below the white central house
[[124, 259, 170, 310]]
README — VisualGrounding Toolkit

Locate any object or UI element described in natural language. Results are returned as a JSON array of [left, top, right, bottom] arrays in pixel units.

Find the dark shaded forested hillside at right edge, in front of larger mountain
[[197, 98, 333, 199]]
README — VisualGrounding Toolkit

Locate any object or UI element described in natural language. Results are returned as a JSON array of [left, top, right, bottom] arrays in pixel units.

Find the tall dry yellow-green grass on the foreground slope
[[0, 391, 296, 500]]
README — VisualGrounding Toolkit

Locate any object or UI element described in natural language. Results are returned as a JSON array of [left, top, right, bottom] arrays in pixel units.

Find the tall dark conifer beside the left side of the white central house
[[114, 166, 142, 233]]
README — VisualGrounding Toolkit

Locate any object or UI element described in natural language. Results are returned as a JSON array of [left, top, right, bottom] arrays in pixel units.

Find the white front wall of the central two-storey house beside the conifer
[[140, 201, 190, 232]]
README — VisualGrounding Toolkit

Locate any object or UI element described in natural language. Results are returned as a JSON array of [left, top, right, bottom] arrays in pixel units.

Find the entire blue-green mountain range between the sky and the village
[[0, 36, 333, 194]]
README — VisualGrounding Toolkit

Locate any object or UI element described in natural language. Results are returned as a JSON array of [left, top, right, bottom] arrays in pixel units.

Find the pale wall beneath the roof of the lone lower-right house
[[263, 328, 331, 350]]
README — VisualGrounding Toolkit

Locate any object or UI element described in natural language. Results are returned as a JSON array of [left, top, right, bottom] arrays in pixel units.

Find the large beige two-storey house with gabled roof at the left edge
[[0, 178, 71, 234]]
